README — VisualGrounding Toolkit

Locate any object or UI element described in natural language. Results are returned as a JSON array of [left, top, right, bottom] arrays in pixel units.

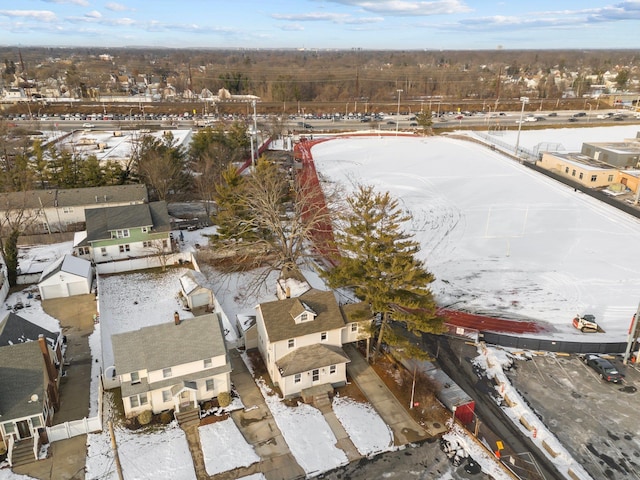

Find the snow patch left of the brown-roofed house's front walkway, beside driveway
[[257, 379, 349, 475]]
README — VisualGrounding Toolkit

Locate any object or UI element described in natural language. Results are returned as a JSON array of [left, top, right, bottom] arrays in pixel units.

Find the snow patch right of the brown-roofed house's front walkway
[[332, 395, 394, 456]]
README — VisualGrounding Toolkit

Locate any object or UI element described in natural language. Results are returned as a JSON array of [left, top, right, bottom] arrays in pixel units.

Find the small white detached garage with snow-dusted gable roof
[[38, 255, 93, 300]]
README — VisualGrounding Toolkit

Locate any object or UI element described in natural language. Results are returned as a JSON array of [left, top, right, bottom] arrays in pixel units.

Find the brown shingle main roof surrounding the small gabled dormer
[[260, 289, 345, 342]]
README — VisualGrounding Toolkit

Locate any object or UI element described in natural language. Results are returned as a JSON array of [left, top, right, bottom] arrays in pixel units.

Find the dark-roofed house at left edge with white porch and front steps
[[0, 336, 62, 461]]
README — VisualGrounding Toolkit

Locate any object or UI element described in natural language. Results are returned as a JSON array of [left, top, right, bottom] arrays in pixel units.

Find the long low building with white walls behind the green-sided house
[[0, 185, 148, 233]]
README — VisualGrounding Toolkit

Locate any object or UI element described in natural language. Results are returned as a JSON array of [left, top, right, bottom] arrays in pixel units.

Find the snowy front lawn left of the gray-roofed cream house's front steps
[[87, 422, 196, 480]]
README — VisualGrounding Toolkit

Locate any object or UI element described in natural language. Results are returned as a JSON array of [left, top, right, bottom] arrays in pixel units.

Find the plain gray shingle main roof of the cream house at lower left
[[111, 313, 227, 374]]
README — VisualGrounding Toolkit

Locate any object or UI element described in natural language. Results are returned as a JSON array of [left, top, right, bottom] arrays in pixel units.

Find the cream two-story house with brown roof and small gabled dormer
[[256, 289, 372, 398]]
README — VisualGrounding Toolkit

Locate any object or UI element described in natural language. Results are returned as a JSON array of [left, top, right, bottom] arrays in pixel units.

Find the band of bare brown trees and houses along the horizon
[[0, 46, 639, 107]]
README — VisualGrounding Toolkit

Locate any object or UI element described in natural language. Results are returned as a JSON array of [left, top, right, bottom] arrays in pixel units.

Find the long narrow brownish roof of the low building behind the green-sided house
[[0, 185, 148, 210]]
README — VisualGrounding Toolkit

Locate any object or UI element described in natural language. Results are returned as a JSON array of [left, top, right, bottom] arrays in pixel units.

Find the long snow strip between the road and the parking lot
[[473, 346, 592, 480]]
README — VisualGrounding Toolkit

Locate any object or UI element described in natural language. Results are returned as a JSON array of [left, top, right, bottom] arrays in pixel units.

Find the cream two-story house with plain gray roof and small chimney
[[111, 312, 231, 417]]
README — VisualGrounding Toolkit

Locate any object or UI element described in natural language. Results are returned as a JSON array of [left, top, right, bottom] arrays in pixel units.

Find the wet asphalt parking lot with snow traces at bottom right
[[508, 354, 640, 480]]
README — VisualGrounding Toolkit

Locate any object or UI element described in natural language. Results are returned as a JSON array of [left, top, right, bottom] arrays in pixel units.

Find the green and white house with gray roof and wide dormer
[[73, 202, 172, 263]]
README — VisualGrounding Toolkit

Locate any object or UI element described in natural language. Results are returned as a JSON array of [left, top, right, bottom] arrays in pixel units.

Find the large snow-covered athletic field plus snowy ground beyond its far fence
[[312, 126, 640, 341]]
